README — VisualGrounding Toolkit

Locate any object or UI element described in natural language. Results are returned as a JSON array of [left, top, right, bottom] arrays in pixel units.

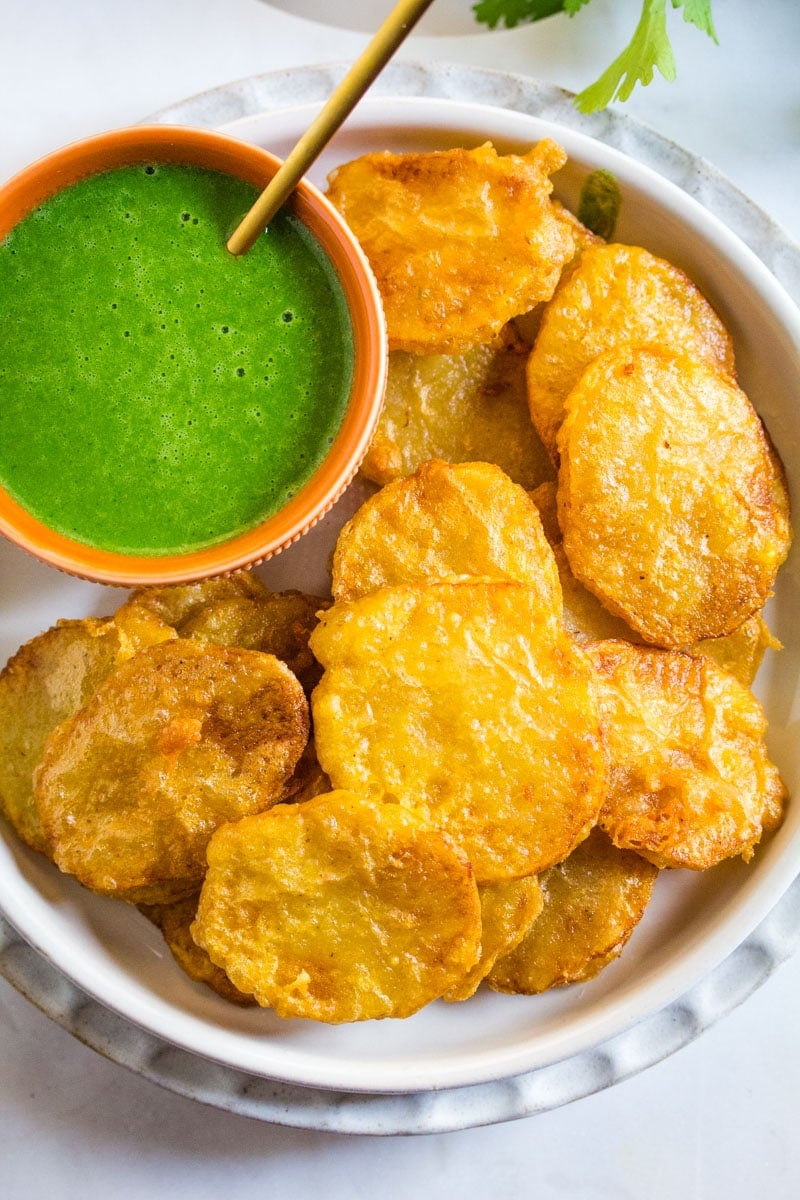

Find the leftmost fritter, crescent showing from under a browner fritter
[[0, 613, 175, 854]]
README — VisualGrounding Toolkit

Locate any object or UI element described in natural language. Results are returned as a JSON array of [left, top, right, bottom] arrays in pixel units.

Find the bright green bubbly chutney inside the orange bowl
[[0, 163, 354, 556]]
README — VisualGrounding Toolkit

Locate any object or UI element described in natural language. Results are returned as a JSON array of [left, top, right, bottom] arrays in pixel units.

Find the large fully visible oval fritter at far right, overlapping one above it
[[558, 346, 790, 648]]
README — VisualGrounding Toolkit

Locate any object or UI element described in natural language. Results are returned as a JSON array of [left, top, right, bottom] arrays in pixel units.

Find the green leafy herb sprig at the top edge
[[473, 0, 717, 113]]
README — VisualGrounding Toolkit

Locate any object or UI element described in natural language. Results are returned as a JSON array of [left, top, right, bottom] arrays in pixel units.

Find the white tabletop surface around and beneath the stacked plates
[[0, 0, 800, 1200]]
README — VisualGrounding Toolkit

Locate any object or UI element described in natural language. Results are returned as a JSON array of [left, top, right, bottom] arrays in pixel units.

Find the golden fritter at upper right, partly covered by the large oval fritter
[[528, 242, 735, 462]]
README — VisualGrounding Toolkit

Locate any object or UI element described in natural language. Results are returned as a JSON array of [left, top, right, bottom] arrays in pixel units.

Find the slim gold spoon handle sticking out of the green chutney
[[228, 0, 433, 254]]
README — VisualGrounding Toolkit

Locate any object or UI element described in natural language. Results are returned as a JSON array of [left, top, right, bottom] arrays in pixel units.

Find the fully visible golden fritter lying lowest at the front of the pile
[[192, 791, 481, 1024]]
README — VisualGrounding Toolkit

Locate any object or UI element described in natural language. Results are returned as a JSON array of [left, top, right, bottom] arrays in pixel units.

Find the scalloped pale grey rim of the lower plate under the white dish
[[0, 64, 800, 1134]]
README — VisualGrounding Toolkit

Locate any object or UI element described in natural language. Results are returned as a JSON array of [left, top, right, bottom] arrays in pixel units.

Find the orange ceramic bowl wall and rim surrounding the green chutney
[[0, 126, 386, 587]]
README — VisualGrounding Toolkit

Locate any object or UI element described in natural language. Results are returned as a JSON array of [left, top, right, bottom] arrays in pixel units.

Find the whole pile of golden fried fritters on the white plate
[[0, 142, 790, 1022]]
